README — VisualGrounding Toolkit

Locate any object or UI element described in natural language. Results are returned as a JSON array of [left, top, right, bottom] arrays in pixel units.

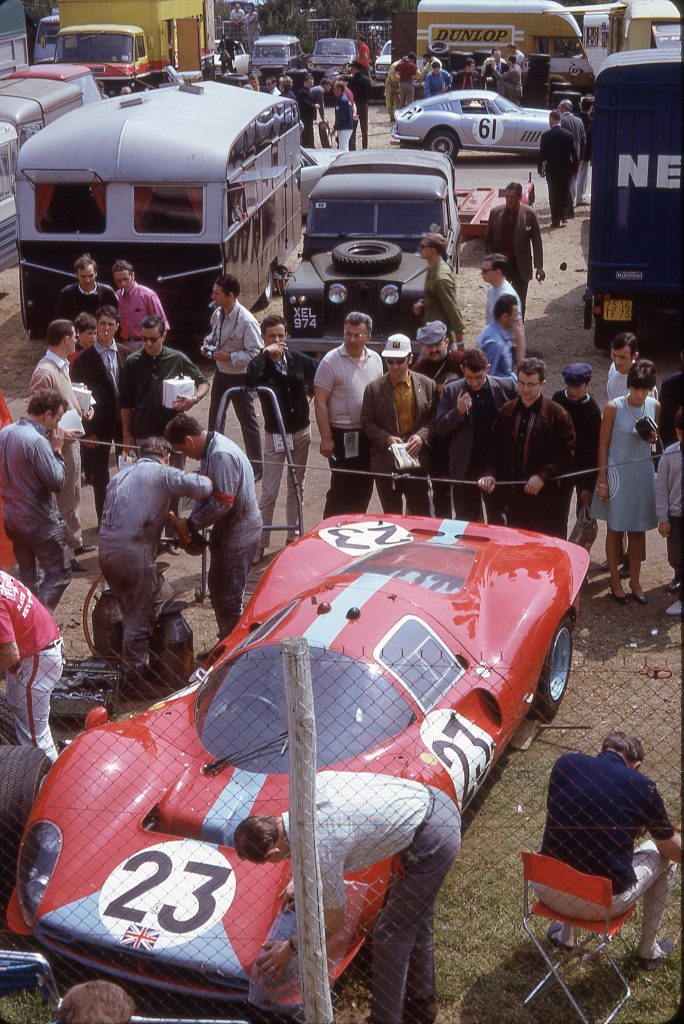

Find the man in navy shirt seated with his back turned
[[532, 732, 682, 971]]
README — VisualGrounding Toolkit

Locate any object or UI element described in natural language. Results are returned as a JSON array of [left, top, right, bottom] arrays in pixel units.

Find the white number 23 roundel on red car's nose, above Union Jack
[[98, 839, 236, 951]]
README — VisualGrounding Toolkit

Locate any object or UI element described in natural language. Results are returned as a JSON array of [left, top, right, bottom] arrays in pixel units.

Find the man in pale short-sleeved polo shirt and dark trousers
[[313, 312, 383, 519]]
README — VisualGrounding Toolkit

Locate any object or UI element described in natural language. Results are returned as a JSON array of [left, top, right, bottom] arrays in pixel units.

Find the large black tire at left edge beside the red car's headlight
[[0, 746, 51, 921]]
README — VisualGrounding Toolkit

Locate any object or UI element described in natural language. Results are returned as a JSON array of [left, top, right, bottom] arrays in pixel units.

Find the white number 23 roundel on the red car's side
[[421, 708, 496, 809]]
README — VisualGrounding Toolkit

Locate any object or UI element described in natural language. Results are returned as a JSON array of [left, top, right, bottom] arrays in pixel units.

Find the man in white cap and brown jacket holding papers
[[361, 334, 437, 515]]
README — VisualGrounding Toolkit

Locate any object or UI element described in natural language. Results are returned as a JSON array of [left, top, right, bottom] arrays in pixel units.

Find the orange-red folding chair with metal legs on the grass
[[520, 850, 635, 1024]]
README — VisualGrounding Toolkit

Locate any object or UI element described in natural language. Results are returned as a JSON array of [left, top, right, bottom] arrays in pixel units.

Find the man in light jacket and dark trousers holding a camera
[[202, 273, 263, 480]]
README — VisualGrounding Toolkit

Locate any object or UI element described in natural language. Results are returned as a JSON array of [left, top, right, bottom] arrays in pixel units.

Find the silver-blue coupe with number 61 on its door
[[391, 89, 549, 160]]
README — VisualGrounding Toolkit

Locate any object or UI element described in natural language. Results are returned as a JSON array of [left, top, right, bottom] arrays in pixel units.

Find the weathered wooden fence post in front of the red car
[[281, 637, 333, 1024]]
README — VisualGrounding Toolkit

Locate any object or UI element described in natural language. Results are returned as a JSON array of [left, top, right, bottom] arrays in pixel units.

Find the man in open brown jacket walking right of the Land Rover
[[484, 181, 546, 319]]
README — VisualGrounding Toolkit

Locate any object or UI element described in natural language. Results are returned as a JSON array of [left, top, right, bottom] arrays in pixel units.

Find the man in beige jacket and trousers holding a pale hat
[[29, 319, 95, 572]]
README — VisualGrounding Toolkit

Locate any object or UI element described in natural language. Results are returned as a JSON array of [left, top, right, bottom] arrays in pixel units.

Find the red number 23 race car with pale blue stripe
[[8, 516, 589, 1005]]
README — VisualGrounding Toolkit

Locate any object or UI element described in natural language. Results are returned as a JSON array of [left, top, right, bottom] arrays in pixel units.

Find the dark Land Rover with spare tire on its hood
[[283, 150, 459, 352]]
